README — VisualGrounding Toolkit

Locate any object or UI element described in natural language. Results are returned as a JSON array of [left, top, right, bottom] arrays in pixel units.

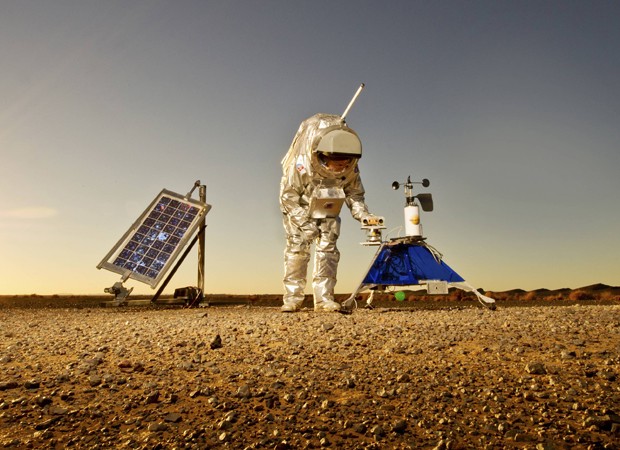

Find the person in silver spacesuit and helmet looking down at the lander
[[280, 114, 375, 312]]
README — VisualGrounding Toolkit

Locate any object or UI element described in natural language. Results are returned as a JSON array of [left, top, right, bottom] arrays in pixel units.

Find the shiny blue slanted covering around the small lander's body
[[362, 243, 464, 286]]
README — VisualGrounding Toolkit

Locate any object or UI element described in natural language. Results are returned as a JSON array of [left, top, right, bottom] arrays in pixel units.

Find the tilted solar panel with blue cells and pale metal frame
[[97, 189, 211, 288]]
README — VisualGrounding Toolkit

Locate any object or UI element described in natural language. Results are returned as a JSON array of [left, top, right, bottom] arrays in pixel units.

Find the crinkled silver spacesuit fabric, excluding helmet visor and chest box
[[280, 114, 370, 309]]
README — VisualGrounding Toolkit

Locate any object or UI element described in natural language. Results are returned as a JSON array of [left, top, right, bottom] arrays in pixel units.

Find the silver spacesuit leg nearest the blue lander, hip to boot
[[312, 217, 340, 311]]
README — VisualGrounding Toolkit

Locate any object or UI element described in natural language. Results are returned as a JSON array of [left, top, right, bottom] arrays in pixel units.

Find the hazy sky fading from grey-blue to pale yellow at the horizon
[[0, 0, 620, 295]]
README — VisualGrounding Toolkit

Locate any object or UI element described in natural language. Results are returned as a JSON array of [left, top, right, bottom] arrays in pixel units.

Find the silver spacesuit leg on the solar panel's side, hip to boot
[[282, 216, 310, 312]]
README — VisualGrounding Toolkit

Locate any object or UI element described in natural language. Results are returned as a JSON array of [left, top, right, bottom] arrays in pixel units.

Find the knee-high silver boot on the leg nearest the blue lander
[[312, 243, 341, 311]]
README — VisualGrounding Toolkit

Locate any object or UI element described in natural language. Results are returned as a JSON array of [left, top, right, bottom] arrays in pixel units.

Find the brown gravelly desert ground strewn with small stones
[[0, 302, 620, 449]]
